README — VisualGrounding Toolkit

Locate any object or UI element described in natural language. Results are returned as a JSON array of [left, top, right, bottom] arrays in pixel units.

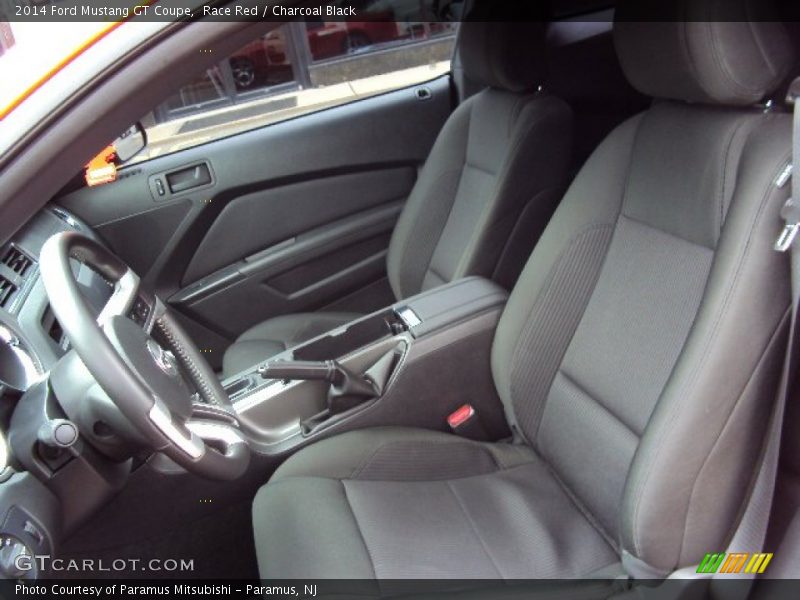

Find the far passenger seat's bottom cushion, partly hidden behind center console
[[217, 313, 362, 377]]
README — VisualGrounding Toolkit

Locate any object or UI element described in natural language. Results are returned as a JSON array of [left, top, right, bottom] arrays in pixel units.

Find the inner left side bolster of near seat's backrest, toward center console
[[492, 115, 643, 426]]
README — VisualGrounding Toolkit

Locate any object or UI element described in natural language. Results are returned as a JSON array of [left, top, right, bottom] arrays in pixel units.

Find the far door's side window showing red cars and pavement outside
[[134, 19, 458, 162]]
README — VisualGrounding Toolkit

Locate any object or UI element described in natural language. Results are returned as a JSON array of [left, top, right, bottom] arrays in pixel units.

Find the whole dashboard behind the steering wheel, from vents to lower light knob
[[0, 205, 156, 580]]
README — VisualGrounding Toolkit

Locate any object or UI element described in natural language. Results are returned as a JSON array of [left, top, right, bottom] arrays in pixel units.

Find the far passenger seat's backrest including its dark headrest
[[387, 22, 572, 299]]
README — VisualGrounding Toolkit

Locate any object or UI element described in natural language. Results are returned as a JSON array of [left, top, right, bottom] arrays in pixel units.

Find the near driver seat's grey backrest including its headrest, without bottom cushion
[[492, 5, 792, 575]]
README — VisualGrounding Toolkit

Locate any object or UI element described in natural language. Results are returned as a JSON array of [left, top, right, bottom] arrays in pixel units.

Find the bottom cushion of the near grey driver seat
[[253, 428, 619, 579]]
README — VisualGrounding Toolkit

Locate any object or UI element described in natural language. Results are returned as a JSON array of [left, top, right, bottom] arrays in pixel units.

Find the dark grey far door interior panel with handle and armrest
[[57, 77, 451, 365]]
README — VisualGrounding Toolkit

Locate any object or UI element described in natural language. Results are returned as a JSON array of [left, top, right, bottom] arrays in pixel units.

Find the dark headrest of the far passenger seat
[[459, 20, 546, 92]]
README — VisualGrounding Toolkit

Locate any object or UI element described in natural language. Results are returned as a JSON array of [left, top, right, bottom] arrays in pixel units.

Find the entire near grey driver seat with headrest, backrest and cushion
[[253, 8, 792, 579]]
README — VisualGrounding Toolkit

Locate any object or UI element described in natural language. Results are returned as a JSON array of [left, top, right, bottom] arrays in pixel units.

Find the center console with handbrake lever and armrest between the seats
[[223, 277, 509, 455]]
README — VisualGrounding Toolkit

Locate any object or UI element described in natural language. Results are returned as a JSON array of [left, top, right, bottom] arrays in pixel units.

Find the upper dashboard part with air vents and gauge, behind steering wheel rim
[[0, 206, 113, 399]]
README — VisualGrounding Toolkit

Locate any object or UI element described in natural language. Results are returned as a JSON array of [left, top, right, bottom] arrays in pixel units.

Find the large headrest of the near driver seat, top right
[[614, 0, 794, 106]]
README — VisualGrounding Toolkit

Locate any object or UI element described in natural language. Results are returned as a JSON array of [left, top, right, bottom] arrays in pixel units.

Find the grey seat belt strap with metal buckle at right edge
[[712, 77, 800, 598]]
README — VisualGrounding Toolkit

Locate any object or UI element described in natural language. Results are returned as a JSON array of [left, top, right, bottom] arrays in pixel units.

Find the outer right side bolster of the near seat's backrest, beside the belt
[[621, 114, 791, 571]]
